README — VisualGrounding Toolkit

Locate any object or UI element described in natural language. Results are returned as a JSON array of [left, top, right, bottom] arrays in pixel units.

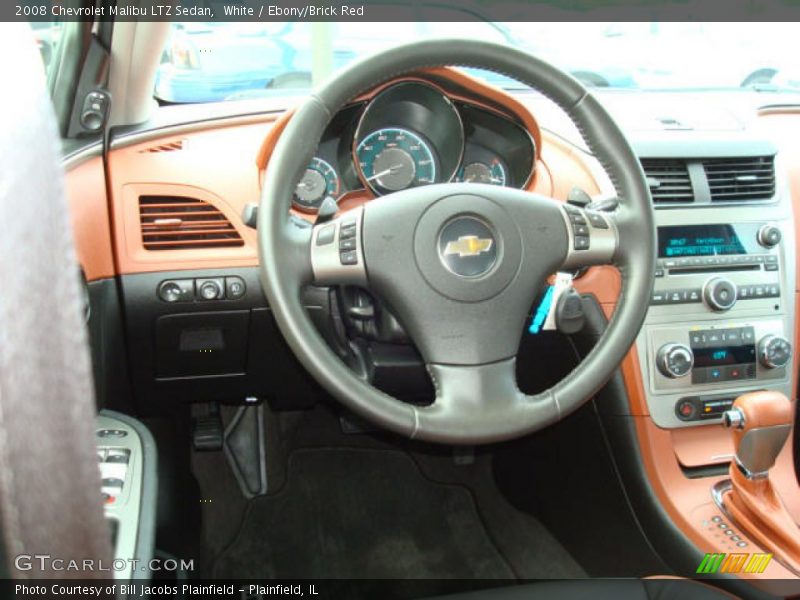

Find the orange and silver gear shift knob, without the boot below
[[722, 391, 792, 479]]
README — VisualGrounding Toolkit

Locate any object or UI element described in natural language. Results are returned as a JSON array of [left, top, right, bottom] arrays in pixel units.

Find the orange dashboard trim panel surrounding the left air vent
[[108, 115, 277, 274]]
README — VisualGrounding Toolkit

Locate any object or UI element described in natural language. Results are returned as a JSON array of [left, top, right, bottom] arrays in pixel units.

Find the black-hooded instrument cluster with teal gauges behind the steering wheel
[[293, 81, 536, 213]]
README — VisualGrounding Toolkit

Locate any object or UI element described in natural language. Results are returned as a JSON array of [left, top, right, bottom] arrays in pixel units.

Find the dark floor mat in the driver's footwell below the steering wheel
[[214, 449, 514, 579]]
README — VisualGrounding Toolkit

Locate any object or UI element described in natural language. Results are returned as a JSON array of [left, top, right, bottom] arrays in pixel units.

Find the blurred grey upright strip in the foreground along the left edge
[[0, 24, 113, 579]]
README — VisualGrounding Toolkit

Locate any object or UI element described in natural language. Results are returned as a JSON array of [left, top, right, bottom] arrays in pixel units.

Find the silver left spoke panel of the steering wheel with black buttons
[[311, 207, 367, 286]]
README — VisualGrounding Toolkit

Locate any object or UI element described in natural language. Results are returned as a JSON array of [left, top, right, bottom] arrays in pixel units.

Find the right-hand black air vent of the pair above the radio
[[703, 156, 775, 202]]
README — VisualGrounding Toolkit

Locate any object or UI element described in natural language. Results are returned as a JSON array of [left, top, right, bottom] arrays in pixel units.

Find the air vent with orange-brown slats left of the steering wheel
[[139, 196, 244, 250]]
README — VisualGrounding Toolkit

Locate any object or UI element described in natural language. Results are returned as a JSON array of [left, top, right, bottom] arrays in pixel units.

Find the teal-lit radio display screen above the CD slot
[[658, 223, 763, 258]]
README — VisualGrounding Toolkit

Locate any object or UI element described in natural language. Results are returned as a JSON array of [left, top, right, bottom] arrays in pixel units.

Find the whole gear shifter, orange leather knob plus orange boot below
[[723, 391, 800, 571]]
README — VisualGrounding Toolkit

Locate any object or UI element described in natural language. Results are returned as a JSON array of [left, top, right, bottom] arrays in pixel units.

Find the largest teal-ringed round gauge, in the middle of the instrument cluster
[[356, 128, 436, 194]]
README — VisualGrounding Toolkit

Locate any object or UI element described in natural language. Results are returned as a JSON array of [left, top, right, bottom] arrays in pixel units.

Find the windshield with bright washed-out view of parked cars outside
[[155, 21, 800, 103]]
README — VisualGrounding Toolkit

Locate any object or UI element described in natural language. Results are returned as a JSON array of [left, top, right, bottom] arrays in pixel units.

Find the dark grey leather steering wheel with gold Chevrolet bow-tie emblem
[[258, 40, 655, 444]]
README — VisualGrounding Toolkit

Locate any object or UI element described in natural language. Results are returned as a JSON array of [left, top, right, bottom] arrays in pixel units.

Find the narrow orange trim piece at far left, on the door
[[65, 157, 115, 281]]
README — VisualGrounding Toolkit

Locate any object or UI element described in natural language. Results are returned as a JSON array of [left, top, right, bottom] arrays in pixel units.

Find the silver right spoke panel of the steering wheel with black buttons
[[561, 204, 619, 270]]
